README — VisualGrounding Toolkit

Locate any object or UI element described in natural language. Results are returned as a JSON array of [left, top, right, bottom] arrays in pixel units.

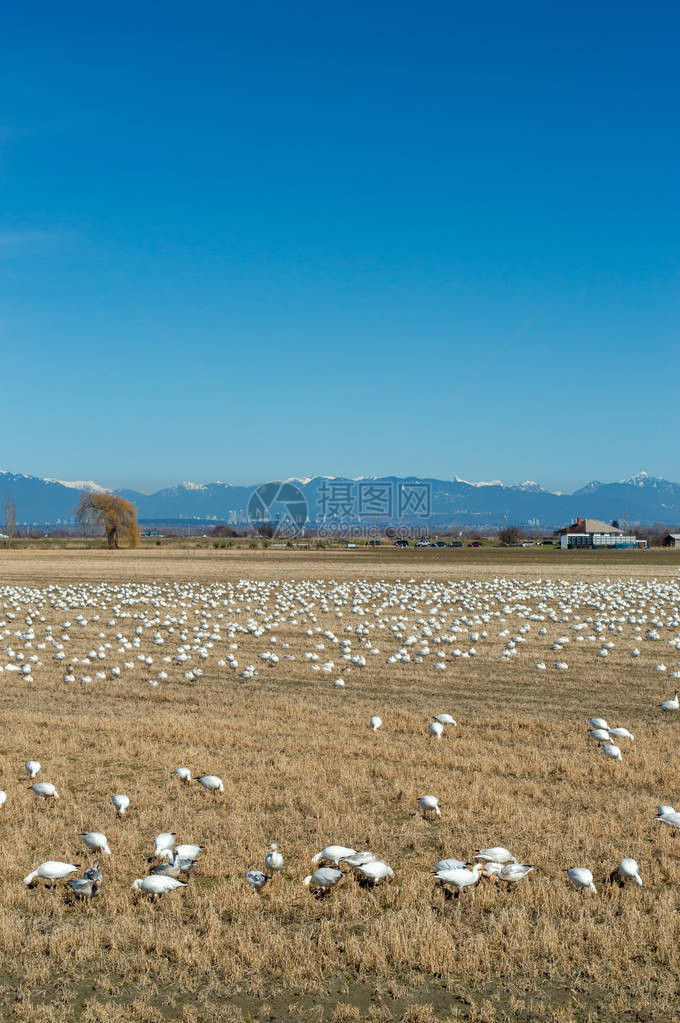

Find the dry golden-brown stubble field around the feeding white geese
[[0, 551, 680, 1023]]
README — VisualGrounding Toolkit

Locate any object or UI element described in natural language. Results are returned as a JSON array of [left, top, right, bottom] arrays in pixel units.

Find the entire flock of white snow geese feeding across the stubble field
[[0, 578, 680, 901]]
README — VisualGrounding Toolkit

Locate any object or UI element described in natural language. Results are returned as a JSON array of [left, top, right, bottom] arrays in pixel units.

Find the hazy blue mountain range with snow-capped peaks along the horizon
[[0, 472, 680, 529]]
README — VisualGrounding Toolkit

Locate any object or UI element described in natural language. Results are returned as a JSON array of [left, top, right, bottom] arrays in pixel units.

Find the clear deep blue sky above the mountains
[[0, 0, 680, 491]]
